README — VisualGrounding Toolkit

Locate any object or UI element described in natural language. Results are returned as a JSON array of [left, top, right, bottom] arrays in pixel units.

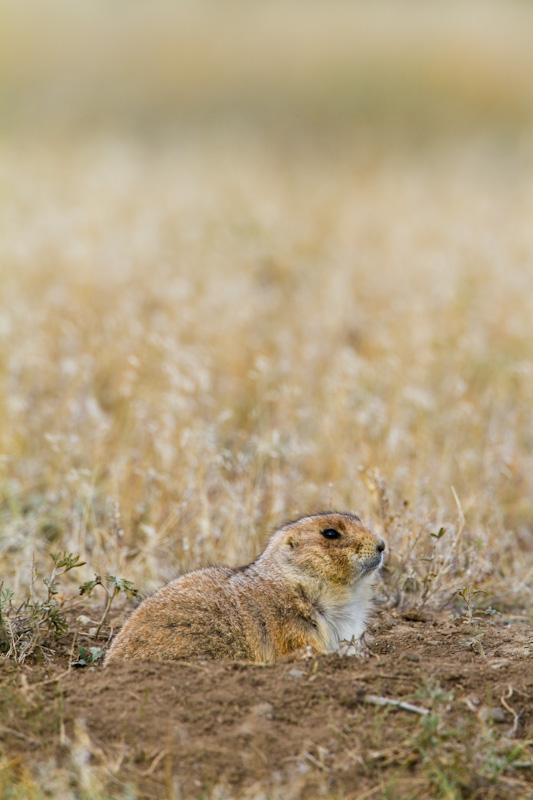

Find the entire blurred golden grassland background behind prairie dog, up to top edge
[[0, 0, 533, 607]]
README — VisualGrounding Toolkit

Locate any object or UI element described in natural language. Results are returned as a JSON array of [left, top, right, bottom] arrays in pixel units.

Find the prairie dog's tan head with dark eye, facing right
[[266, 512, 385, 586]]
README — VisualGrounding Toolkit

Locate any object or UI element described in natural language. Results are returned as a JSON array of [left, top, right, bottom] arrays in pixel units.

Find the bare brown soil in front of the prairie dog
[[0, 610, 533, 800]]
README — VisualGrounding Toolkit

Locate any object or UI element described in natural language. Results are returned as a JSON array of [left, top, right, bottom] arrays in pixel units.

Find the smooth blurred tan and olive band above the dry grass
[[2, 0, 533, 143]]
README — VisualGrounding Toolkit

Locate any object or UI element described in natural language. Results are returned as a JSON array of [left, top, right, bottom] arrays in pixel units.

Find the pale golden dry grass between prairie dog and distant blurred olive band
[[0, 135, 533, 602]]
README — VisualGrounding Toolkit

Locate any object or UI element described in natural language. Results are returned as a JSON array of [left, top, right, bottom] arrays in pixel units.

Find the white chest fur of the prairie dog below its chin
[[320, 573, 375, 655]]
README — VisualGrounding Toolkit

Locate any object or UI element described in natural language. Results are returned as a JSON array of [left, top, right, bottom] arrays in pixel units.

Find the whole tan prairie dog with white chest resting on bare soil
[[105, 512, 385, 664]]
